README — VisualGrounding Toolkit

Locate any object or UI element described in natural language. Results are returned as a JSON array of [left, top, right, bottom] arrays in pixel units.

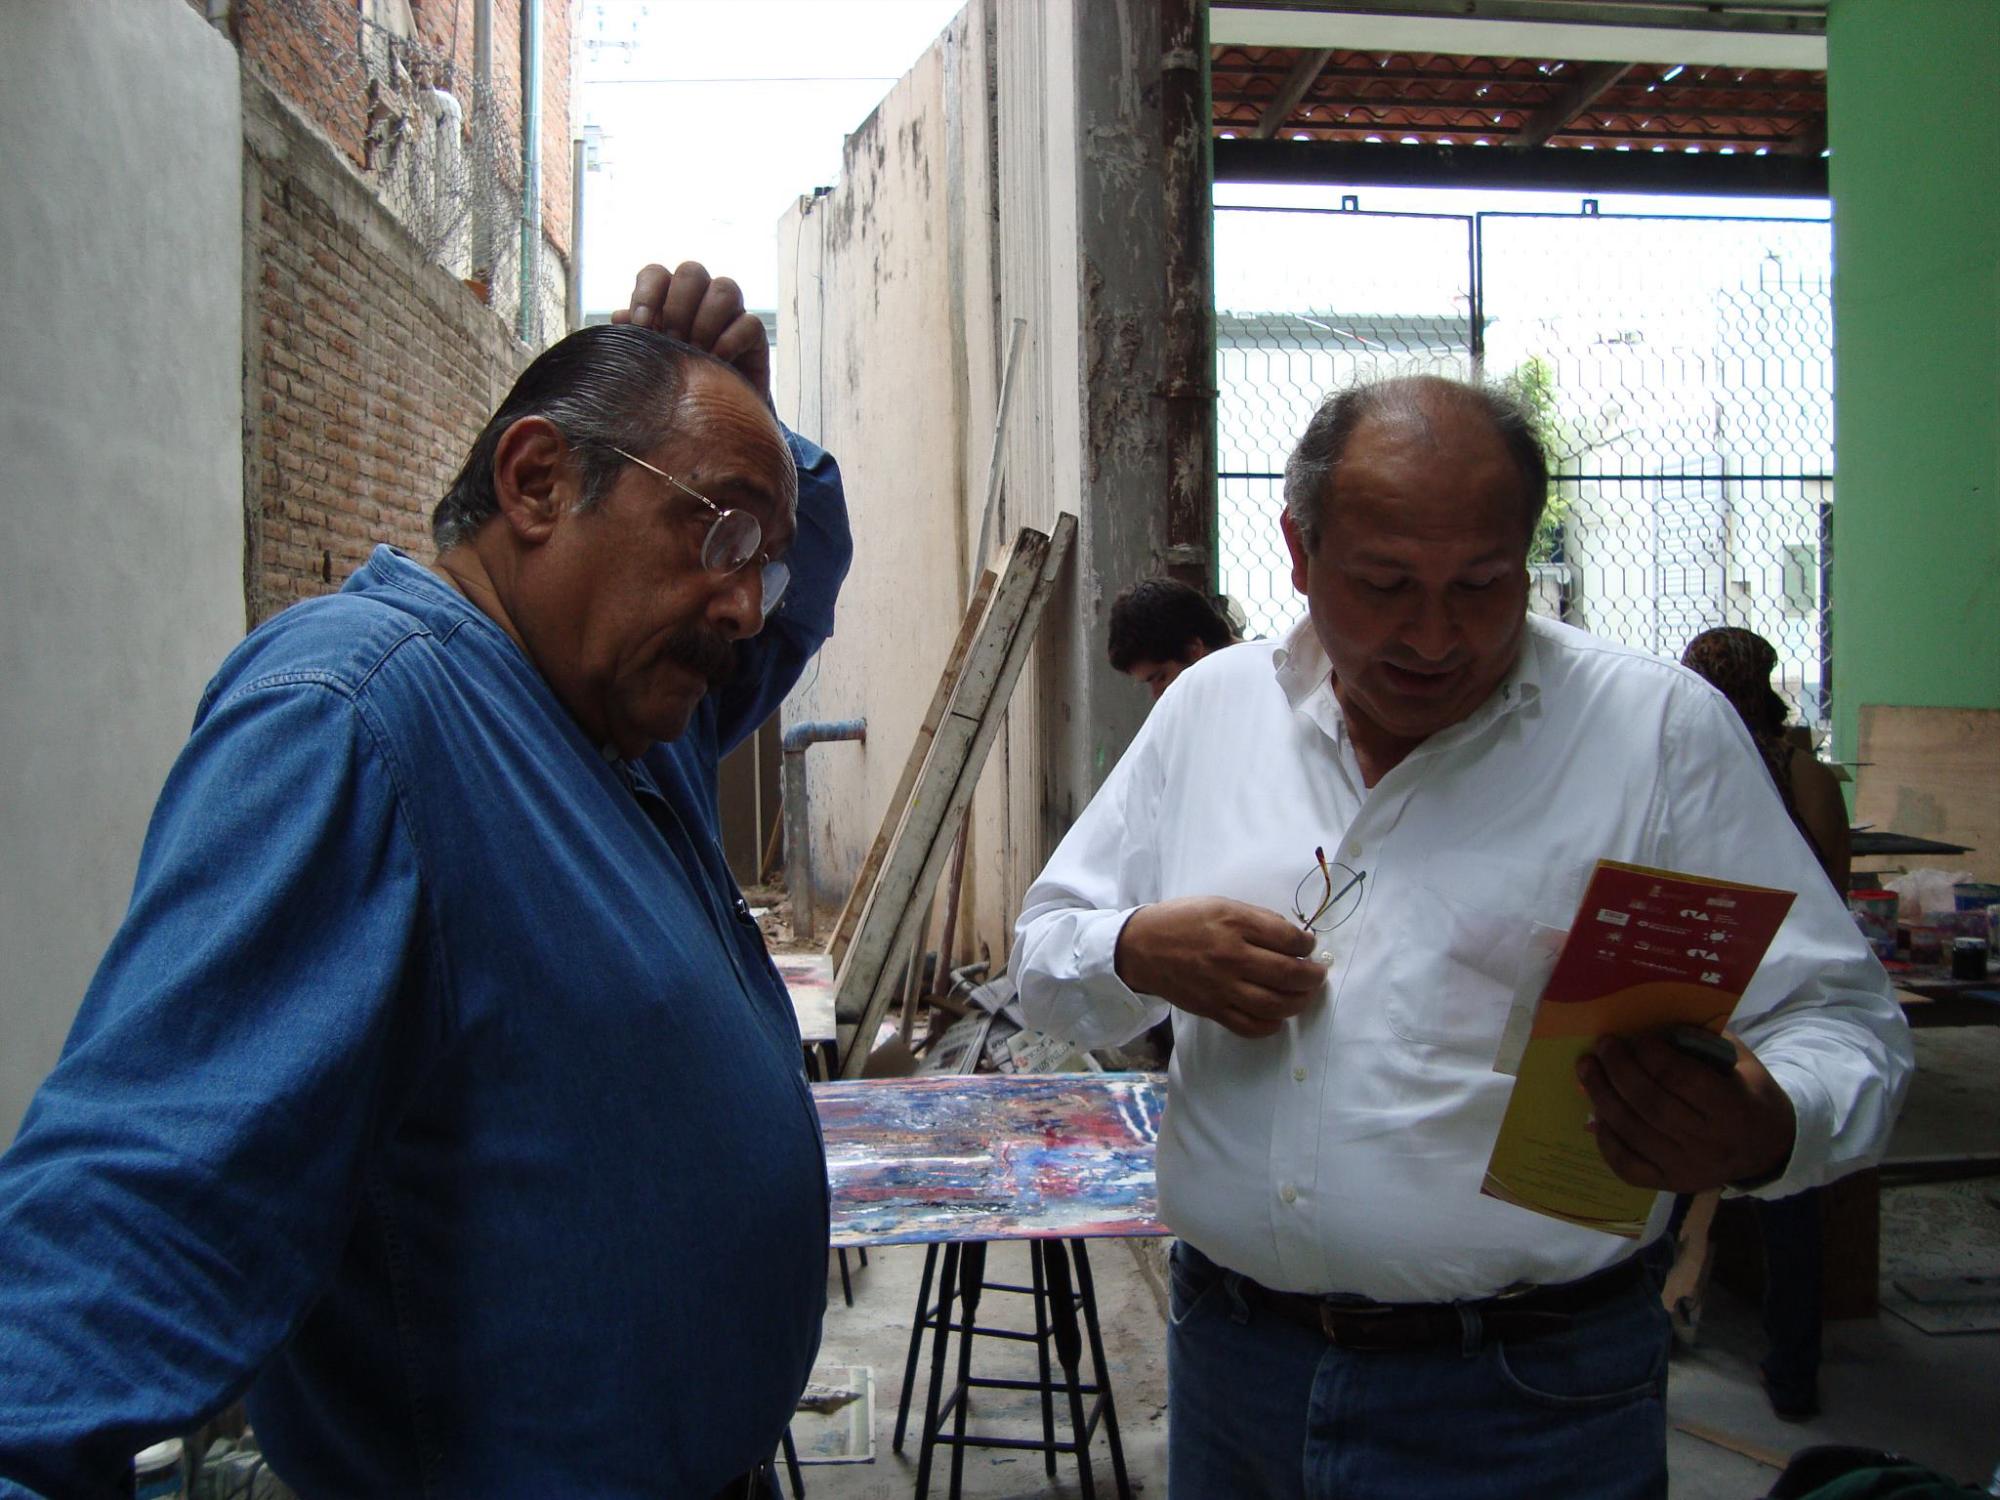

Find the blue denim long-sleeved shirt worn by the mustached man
[[0, 438, 850, 1498]]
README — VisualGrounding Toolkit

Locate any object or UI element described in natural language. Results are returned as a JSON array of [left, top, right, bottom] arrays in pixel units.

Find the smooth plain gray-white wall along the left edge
[[0, 0, 244, 1144]]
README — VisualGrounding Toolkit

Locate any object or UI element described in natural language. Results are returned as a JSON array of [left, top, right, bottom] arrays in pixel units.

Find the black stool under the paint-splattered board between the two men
[[892, 1240, 1132, 1500]]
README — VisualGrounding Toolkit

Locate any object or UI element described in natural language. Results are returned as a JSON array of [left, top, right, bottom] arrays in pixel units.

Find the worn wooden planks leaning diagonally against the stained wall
[[828, 512, 1076, 1078]]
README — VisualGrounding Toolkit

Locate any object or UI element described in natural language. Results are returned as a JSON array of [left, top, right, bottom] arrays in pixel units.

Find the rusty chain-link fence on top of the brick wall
[[249, 0, 568, 348]]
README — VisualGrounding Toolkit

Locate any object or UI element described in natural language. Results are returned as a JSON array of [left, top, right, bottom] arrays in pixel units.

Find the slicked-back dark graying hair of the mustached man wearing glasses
[[430, 324, 772, 554]]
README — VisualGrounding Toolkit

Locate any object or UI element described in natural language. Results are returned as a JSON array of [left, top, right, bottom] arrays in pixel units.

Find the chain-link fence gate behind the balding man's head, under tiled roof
[[1216, 208, 1834, 732]]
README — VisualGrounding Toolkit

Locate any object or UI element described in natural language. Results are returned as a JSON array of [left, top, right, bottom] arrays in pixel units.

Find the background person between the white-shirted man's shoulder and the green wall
[[1680, 626, 1850, 1422]]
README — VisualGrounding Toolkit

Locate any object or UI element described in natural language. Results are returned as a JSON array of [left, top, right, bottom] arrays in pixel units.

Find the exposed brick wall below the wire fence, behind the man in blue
[[244, 70, 528, 624]]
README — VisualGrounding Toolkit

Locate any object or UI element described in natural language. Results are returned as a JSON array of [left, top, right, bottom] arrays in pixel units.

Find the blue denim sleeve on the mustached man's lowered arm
[[0, 676, 434, 1496]]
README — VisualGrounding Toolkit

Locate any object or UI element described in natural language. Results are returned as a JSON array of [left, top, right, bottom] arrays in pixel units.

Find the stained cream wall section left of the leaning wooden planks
[[774, 10, 996, 952]]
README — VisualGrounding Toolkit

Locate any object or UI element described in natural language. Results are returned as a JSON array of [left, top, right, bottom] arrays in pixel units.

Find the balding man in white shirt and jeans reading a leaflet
[[1014, 376, 1910, 1500]]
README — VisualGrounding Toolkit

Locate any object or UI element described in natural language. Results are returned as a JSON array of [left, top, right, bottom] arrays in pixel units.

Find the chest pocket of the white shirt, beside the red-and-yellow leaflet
[[1384, 854, 1550, 1064]]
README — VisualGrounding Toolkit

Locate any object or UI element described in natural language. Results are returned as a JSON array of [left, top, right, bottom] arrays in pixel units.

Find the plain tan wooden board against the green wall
[[1854, 704, 2000, 880]]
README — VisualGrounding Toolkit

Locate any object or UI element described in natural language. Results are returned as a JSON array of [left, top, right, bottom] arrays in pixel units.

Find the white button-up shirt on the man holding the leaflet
[[1014, 618, 1912, 1302]]
